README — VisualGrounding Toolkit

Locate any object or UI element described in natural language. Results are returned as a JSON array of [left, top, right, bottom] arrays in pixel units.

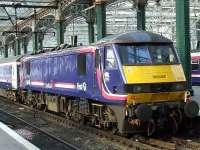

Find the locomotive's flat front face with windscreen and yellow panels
[[116, 42, 186, 104]]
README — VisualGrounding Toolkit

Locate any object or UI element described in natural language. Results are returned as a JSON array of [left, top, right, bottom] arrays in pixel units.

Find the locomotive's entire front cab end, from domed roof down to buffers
[[99, 32, 199, 135]]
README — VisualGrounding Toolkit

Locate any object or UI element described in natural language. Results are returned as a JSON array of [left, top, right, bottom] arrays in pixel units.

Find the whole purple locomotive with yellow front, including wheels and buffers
[[0, 31, 199, 135]]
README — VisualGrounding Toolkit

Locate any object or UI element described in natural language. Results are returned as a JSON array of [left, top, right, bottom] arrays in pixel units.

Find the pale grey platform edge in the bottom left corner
[[0, 122, 39, 150]]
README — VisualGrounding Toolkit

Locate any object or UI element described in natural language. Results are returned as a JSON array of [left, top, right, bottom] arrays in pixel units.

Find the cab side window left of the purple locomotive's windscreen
[[105, 47, 117, 69]]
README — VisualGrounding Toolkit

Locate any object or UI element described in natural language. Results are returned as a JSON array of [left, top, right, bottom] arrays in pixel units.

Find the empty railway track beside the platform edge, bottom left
[[0, 109, 80, 150]]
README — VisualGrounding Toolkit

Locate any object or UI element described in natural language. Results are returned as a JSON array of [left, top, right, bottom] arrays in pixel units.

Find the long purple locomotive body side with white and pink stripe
[[21, 47, 127, 105]]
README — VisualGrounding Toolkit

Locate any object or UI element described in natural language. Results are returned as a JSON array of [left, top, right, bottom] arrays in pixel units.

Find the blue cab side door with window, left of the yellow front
[[103, 46, 121, 93]]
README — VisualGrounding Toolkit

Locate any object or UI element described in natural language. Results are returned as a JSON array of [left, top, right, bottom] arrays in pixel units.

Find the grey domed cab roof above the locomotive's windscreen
[[97, 31, 172, 45]]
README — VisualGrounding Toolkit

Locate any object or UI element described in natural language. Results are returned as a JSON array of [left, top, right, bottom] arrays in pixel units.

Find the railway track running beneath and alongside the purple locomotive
[[0, 100, 200, 150]]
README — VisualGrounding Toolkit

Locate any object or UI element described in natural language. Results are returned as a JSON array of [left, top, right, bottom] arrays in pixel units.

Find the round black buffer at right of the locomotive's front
[[184, 101, 199, 118]]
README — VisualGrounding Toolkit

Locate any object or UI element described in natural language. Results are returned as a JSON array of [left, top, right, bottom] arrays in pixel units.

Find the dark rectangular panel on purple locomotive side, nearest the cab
[[77, 54, 86, 75]]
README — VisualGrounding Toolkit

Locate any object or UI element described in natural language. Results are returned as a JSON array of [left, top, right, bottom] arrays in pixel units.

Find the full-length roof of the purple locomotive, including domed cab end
[[22, 31, 172, 60]]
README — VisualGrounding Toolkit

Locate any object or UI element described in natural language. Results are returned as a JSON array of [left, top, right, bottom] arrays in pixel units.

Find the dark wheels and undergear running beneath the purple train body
[[0, 89, 196, 135]]
